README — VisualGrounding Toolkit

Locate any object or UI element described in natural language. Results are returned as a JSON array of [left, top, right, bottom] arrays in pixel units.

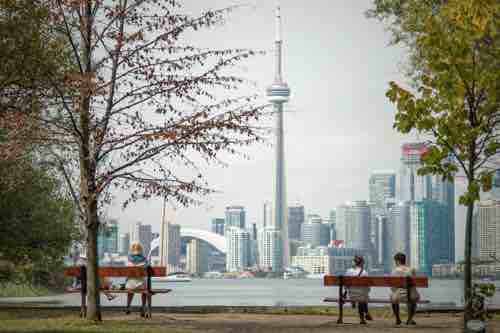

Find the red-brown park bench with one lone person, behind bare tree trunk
[[64, 266, 172, 318]]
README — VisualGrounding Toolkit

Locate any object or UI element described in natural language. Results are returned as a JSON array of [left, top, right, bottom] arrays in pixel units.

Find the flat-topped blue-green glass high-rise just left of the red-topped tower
[[369, 170, 396, 214]]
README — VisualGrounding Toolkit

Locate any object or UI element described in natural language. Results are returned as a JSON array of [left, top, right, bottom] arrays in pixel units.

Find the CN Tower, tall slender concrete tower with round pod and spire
[[266, 7, 290, 269]]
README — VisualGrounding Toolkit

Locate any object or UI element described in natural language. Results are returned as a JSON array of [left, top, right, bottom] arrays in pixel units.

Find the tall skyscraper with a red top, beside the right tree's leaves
[[397, 143, 432, 201]]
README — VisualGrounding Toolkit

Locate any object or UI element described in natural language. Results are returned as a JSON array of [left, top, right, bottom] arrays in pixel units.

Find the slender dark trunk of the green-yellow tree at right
[[464, 198, 474, 328]]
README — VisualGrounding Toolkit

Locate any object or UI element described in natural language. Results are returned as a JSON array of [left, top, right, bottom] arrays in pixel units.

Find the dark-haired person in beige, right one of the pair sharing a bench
[[391, 252, 420, 325]]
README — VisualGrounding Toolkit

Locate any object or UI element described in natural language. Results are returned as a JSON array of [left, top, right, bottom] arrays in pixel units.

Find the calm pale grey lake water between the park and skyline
[[51, 279, 500, 306]]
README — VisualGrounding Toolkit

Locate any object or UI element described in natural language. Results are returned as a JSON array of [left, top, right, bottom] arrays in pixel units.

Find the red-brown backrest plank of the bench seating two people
[[323, 275, 429, 288]]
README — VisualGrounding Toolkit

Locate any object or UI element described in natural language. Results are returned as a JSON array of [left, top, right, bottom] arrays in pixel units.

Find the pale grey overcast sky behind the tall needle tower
[[107, 0, 465, 259]]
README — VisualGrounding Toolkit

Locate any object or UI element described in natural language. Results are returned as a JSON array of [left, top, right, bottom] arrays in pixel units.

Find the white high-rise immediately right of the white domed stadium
[[225, 227, 250, 272]]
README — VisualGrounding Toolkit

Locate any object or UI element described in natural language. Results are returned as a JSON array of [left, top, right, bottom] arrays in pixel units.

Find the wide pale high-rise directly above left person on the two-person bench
[[337, 201, 371, 252]]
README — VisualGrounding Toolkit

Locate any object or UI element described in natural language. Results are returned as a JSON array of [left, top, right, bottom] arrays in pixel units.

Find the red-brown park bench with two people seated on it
[[323, 275, 430, 324]]
